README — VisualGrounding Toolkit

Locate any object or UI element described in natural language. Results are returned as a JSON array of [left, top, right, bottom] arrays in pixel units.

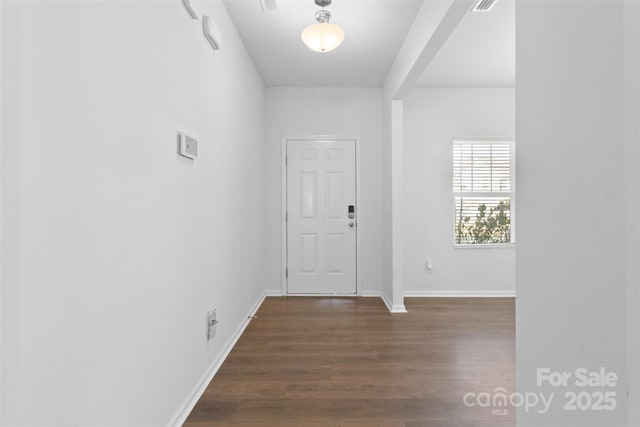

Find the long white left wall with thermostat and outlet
[[2, 1, 264, 425]]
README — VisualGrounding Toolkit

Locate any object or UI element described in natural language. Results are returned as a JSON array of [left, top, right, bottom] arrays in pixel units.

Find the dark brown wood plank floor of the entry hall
[[185, 297, 515, 427]]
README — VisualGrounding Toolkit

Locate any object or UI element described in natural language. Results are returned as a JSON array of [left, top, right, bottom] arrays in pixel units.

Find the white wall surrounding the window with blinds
[[404, 88, 517, 295]]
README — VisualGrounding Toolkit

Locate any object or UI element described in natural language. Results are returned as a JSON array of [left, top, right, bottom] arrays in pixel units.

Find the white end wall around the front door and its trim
[[264, 87, 382, 292]]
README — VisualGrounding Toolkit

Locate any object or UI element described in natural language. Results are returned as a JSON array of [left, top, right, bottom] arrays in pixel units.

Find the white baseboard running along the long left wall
[[168, 291, 268, 427]]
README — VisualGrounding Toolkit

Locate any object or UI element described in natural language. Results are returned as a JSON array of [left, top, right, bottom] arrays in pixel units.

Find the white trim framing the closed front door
[[280, 135, 364, 296]]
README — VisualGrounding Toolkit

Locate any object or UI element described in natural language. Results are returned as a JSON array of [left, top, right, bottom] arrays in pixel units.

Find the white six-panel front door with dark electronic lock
[[286, 140, 358, 294]]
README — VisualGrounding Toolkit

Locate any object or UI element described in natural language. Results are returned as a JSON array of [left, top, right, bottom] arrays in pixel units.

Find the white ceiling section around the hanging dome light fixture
[[225, 0, 422, 86]]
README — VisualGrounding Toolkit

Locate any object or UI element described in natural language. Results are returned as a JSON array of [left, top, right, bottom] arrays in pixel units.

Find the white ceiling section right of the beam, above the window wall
[[417, 0, 516, 87]]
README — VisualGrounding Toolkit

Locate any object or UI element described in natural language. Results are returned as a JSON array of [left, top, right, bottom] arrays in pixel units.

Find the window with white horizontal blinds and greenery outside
[[453, 141, 515, 246]]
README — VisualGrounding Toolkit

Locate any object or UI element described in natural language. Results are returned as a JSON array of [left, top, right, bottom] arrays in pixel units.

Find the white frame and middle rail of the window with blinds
[[449, 137, 516, 249]]
